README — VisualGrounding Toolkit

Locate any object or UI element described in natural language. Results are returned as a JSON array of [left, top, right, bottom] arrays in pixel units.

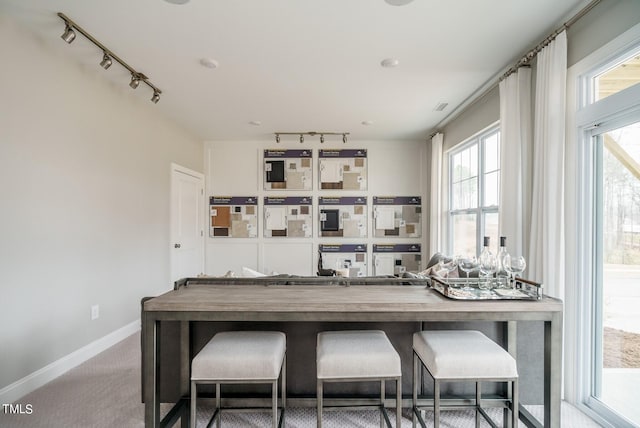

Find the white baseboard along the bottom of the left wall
[[0, 319, 140, 403]]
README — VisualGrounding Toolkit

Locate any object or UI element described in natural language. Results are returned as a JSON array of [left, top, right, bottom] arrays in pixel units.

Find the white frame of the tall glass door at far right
[[564, 24, 640, 427]]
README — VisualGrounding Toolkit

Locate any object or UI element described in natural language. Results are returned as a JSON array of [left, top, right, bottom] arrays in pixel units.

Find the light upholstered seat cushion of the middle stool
[[316, 330, 401, 380]]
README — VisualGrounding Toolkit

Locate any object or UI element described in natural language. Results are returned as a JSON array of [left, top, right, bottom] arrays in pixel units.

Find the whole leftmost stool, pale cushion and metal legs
[[191, 331, 286, 428]]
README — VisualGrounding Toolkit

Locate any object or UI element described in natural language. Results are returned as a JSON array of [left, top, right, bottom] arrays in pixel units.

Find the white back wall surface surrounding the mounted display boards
[[205, 137, 429, 275]]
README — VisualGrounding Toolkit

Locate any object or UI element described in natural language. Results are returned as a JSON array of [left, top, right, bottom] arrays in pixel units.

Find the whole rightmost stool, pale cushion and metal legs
[[413, 330, 518, 428]]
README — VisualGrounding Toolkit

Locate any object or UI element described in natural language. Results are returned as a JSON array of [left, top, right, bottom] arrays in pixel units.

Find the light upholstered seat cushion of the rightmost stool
[[413, 330, 518, 379]]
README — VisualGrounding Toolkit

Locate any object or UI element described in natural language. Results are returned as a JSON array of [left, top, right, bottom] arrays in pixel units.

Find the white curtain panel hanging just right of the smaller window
[[498, 67, 532, 256]]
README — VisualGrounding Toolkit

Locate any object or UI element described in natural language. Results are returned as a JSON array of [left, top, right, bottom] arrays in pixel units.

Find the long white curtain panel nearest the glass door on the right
[[527, 31, 567, 297]]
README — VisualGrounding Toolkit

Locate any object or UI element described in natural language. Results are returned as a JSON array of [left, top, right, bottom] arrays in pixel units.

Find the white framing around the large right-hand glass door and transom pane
[[565, 24, 640, 427]]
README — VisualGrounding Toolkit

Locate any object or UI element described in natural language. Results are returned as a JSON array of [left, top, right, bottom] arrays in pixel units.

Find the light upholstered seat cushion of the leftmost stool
[[191, 331, 286, 381]]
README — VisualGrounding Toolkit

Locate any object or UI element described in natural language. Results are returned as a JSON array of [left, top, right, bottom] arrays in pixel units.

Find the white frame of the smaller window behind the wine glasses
[[446, 122, 501, 254]]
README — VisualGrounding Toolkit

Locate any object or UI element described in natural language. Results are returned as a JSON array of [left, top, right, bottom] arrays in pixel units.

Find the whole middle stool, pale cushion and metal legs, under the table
[[316, 330, 402, 428]]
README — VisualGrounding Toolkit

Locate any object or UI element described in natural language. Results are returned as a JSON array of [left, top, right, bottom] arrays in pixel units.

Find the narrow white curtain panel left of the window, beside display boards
[[429, 132, 444, 257]]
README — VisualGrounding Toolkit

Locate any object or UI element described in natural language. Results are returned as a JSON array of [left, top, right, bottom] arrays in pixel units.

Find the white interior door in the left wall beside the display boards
[[170, 164, 204, 281]]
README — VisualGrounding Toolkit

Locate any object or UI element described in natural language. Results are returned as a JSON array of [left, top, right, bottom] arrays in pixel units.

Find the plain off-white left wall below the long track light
[[0, 17, 203, 392]]
